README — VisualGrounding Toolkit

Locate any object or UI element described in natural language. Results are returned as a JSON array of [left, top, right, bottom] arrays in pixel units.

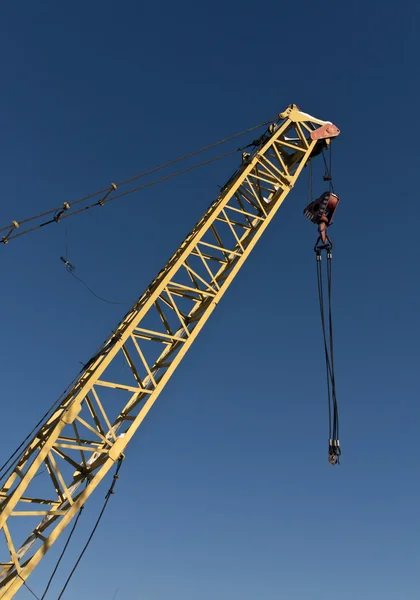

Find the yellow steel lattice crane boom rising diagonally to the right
[[0, 105, 338, 600]]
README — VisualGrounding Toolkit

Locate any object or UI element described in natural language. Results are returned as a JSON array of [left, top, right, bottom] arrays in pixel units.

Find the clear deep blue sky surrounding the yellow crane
[[0, 0, 420, 600]]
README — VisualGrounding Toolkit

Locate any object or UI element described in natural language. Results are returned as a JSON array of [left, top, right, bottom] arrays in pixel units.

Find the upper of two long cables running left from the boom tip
[[0, 117, 278, 241]]
